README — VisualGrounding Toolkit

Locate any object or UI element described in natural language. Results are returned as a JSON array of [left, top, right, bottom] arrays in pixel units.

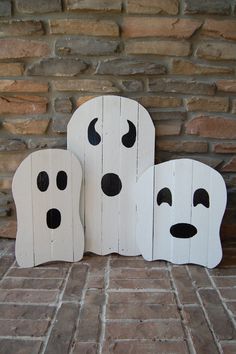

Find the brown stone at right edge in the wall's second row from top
[[201, 19, 236, 40]]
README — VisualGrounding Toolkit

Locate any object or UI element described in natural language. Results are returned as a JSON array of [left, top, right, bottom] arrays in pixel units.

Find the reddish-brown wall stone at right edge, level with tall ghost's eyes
[[186, 115, 236, 139]]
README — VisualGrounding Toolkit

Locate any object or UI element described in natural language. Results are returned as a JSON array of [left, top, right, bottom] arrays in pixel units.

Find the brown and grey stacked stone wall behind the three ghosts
[[0, 0, 236, 240]]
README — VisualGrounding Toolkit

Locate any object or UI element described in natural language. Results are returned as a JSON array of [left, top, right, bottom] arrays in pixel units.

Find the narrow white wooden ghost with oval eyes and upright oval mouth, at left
[[12, 149, 84, 267]]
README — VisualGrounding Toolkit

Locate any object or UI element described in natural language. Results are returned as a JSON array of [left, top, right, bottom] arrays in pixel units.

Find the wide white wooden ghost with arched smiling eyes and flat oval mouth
[[137, 159, 226, 268]]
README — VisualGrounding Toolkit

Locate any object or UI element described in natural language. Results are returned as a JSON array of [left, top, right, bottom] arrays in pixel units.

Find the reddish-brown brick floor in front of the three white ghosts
[[0, 239, 236, 354]]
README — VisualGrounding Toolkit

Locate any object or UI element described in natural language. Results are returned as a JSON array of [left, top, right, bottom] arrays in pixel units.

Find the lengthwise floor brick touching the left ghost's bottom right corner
[[63, 264, 88, 301]]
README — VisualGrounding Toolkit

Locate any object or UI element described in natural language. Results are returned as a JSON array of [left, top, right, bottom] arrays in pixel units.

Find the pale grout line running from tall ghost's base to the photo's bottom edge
[[97, 256, 111, 354]]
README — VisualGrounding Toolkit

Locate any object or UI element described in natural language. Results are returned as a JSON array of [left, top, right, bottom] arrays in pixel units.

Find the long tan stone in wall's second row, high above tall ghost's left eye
[[49, 19, 119, 37]]
